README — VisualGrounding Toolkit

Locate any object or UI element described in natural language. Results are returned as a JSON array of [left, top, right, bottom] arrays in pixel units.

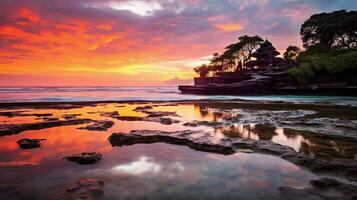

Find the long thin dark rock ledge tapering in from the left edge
[[0, 119, 93, 136]]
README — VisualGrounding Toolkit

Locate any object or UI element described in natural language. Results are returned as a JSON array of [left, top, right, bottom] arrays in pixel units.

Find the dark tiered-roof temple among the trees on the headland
[[245, 40, 284, 71]]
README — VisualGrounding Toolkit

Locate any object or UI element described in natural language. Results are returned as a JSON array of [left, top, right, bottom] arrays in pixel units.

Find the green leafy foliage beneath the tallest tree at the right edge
[[289, 50, 357, 84]]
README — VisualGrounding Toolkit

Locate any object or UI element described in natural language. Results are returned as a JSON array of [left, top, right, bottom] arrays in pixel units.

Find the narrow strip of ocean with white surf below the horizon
[[0, 86, 357, 106]]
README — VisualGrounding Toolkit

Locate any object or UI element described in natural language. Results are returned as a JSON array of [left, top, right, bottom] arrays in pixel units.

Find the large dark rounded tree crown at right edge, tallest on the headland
[[300, 10, 357, 49]]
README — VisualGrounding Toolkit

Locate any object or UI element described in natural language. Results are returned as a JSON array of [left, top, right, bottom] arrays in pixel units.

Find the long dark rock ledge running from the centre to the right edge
[[108, 130, 357, 182]]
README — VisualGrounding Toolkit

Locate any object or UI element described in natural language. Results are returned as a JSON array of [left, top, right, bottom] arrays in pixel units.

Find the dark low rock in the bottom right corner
[[279, 178, 357, 200]]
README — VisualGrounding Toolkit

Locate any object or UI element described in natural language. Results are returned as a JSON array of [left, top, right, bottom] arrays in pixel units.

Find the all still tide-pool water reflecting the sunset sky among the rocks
[[0, 103, 355, 199]]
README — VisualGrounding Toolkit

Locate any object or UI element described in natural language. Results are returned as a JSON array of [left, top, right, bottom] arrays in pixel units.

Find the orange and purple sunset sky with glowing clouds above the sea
[[0, 0, 357, 86]]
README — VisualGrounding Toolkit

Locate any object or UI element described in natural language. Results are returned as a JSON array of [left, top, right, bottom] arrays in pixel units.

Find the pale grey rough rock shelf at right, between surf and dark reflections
[[210, 108, 357, 140]]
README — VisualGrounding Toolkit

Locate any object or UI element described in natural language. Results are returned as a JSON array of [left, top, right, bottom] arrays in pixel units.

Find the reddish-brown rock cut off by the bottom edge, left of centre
[[48, 177, 105, 200]]
